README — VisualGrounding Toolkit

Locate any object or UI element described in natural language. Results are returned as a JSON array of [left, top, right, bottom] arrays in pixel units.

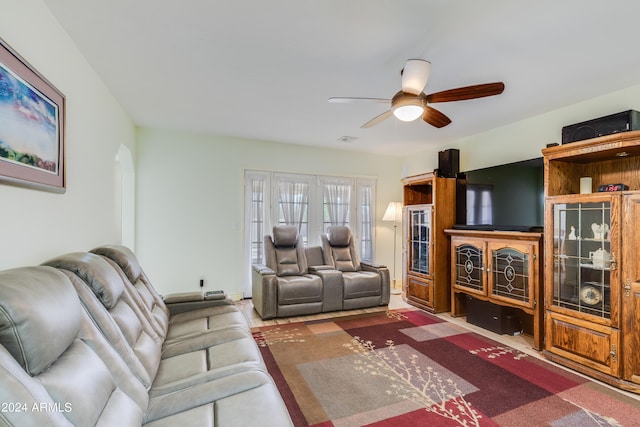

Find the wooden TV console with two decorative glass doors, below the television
[[446, 230, 543, 350]]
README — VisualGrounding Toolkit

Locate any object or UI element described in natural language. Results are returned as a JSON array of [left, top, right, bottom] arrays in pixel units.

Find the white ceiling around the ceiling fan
[[44, 0, 640, 155]]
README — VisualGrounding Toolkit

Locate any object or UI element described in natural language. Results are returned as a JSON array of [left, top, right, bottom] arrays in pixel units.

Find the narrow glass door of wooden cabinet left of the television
[[408, 205, 432, 276]]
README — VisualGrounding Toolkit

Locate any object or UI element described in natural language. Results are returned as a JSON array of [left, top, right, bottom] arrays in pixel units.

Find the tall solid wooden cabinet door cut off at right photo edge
[[621, 194, 640, 384]]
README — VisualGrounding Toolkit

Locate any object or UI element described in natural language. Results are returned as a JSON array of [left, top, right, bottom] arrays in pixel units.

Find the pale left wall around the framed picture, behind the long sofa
[[0, 0, 135, 269]]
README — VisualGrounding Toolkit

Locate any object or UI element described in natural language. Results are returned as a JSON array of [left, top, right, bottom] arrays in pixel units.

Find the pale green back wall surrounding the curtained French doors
[[136, 129, 402, 294]]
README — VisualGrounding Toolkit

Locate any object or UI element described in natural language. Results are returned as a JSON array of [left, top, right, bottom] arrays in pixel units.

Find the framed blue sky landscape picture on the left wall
[[0, 39, 65, 193]]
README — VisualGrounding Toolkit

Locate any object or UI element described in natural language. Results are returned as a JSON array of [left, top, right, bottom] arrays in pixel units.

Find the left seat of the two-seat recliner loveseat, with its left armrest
[[252, 225, 323, 319]]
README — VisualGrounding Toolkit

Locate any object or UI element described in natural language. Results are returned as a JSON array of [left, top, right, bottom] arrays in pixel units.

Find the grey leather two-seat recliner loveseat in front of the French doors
[[252, 225, 391, 319]]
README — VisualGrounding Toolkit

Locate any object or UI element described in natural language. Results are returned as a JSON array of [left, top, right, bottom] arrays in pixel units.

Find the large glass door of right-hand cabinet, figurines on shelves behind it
[[551, 199, 618, 319]]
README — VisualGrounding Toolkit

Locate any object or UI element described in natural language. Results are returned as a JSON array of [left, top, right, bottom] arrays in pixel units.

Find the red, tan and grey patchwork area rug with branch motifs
[[253, 309, 640, 427]]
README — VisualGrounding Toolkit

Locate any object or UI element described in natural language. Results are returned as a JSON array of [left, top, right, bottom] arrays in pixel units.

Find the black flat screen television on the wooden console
[[456, 157, 544, 231]]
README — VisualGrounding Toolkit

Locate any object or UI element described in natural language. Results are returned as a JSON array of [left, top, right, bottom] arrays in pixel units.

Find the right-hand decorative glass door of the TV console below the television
[[487, 242, 538, 308]]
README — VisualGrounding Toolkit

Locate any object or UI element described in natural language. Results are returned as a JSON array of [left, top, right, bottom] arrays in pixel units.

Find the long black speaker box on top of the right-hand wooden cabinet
[[562, 110, 640, 144]]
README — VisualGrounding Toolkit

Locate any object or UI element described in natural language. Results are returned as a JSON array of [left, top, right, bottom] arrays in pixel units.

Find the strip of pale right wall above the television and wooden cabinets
[[404, 82, 640, 175]]
